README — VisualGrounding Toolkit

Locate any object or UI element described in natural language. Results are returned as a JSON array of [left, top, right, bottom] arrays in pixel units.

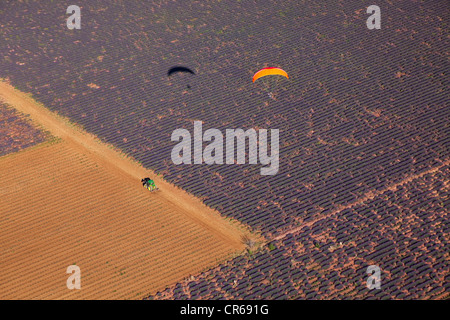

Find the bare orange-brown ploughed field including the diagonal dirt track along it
[[0, 82, 257, 299]]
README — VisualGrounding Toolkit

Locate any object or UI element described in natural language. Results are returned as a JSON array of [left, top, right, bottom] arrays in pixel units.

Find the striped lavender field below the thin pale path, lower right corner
[[150, 166, 450, 300]]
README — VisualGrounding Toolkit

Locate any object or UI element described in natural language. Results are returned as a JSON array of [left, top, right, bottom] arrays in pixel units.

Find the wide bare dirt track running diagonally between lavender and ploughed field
[[0, 78, 265, 251]]
